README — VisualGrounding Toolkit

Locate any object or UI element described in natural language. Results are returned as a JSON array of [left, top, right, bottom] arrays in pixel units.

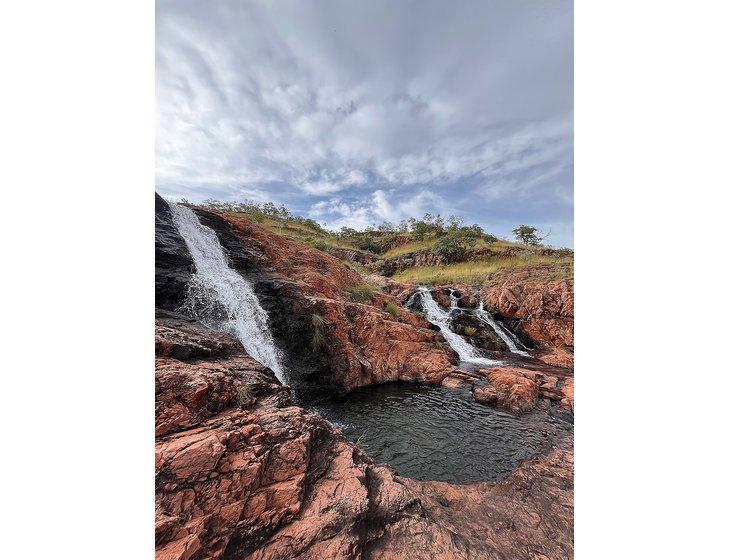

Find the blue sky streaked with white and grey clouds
[[156, 0, 573, 247]]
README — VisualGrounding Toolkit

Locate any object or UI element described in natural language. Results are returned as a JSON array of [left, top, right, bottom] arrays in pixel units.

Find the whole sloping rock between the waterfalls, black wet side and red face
[[191, 209, 457, 391]]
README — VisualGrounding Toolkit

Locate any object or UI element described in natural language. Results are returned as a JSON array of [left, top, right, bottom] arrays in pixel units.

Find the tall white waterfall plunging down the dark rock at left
[[170, 203, 284, 383]]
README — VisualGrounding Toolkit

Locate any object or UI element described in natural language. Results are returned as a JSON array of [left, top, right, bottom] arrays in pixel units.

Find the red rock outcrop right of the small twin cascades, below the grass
[[482, 274, 573, 348]]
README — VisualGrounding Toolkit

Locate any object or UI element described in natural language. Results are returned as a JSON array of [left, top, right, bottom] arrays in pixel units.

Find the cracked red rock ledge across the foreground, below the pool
[[156, 313, 573, 560]]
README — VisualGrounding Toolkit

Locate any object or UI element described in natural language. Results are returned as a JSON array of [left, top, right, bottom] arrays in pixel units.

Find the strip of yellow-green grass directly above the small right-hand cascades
[[393, 255, 573, 284]]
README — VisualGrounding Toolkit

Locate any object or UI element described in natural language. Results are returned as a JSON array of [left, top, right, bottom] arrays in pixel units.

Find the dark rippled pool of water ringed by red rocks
[[315, 384, 557, 483]]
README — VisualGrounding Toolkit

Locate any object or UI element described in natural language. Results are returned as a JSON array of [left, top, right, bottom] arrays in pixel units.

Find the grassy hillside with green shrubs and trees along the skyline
[[196, 201, 573, 287]]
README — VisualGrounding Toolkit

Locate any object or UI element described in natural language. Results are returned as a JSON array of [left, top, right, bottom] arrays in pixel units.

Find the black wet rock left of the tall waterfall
[[155, 193, 195, 310]]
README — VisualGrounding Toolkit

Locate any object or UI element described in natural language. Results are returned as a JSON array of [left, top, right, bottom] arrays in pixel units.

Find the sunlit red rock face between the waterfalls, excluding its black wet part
[[199, 212, 457, 391]]
